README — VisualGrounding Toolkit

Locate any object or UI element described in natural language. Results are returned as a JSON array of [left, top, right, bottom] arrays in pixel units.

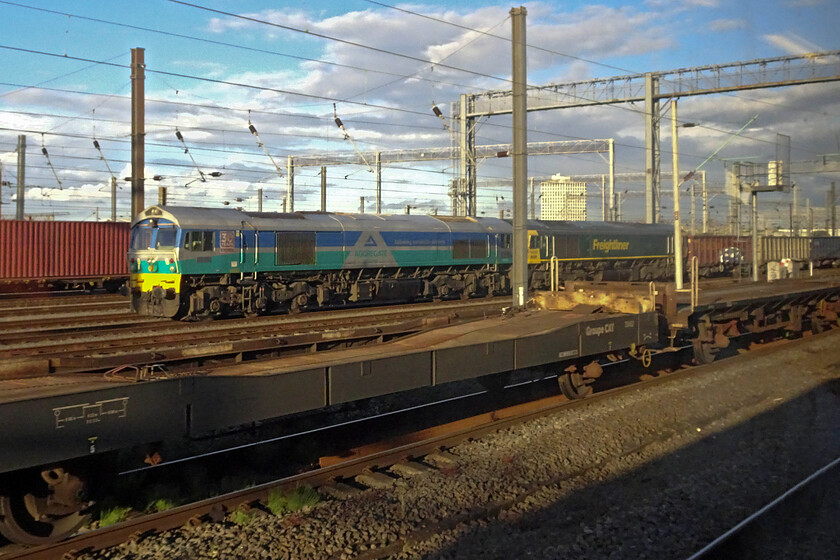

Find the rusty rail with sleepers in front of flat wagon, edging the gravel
[[0, 322, 832, 560]]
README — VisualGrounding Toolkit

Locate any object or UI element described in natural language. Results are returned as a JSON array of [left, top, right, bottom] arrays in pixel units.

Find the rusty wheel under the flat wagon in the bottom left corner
[[0, 468, 92, 545]]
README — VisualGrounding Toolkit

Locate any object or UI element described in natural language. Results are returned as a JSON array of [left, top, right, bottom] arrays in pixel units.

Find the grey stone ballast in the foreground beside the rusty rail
[[79, 332, 840, 559]]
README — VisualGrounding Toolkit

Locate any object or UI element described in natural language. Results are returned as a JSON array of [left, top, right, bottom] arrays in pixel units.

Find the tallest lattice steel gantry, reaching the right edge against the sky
[[453, 51, 840, 223]]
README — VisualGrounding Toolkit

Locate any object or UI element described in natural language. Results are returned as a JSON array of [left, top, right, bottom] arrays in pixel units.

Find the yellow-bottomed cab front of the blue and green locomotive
[[128, 206, 181, 317]]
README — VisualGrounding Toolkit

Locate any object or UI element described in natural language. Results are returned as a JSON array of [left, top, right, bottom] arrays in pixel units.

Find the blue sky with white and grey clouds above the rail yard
[[0, 0, 840, 228]]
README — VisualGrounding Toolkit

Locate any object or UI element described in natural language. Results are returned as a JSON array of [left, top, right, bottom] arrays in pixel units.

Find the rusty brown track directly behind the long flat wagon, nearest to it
[[0, 298, 509, 379]]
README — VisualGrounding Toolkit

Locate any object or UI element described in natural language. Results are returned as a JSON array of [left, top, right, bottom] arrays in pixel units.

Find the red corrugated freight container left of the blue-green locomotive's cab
[[0, 220, 130, 283]]
